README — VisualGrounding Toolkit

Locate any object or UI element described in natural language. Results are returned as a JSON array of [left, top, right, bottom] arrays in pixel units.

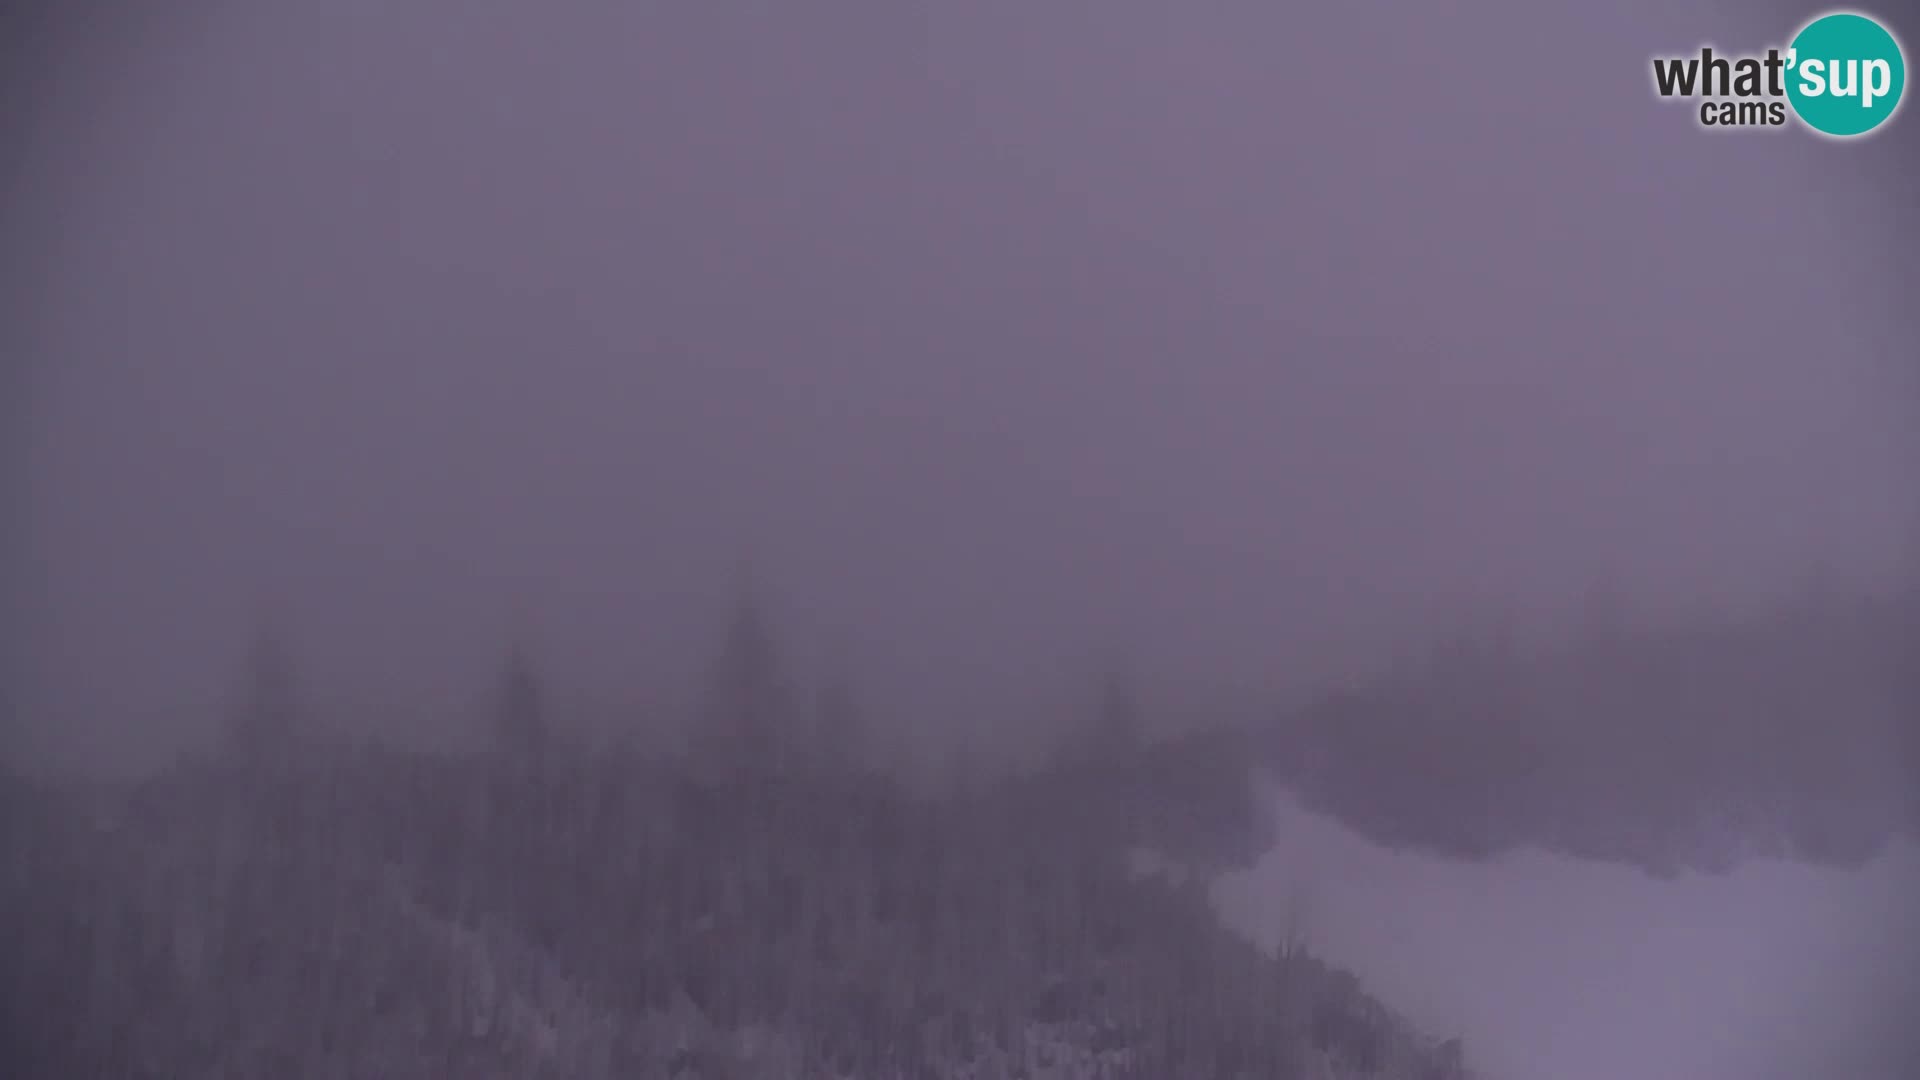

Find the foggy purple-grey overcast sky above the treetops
[[0, 0, 1920, 757]]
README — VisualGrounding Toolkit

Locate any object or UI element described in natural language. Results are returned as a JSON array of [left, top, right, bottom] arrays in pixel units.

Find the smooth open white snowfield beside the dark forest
[[1215, 780, 1920, 1080]]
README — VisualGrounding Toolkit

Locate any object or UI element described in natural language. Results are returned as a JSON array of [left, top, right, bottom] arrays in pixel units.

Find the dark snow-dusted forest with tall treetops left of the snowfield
[[0, 588, 1465, 1080]]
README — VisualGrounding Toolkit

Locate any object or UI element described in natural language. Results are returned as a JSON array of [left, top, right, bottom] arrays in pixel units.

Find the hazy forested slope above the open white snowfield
[[1260, 586, 1920, 876]]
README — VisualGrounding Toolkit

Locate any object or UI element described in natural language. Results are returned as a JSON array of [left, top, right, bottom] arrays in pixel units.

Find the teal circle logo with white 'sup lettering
[[1788, 12, 1907, 138]]
